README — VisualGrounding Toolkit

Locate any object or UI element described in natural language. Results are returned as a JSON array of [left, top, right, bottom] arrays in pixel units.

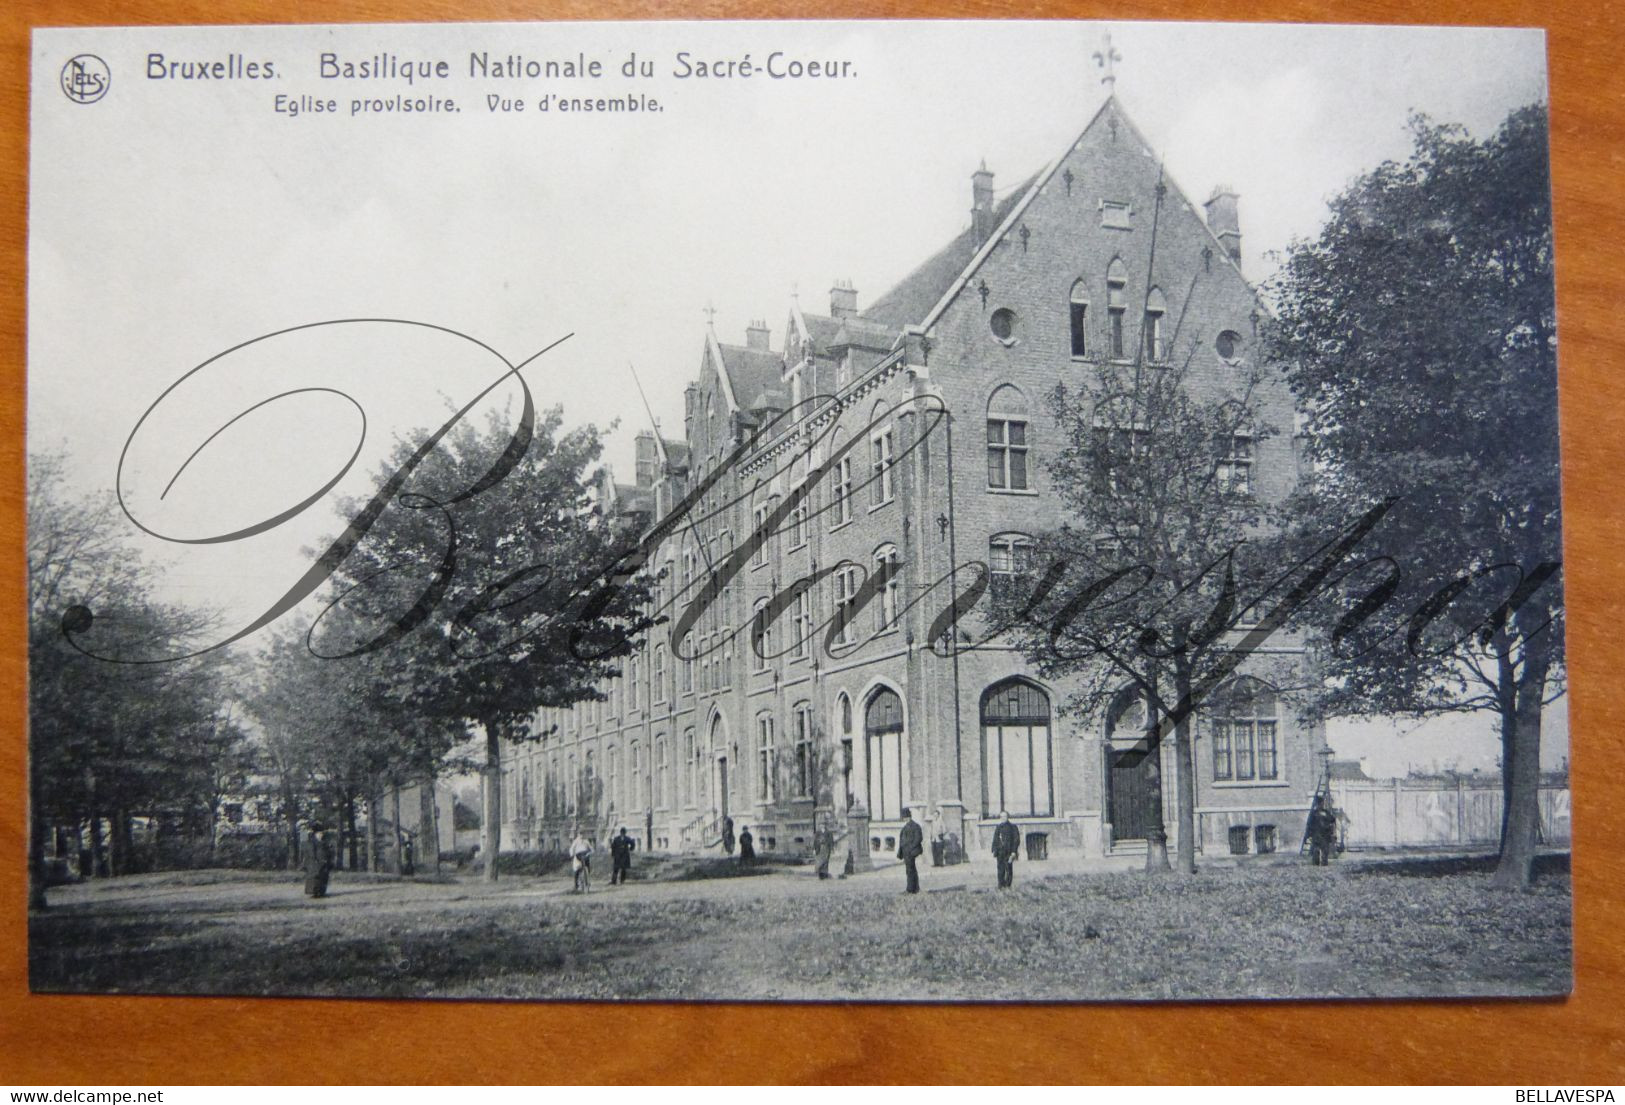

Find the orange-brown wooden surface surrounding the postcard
[[0, 0, 1625, 1087]]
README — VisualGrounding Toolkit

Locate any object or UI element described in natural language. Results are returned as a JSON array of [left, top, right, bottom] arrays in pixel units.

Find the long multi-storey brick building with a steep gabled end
[[504, 96, 1324, 865]]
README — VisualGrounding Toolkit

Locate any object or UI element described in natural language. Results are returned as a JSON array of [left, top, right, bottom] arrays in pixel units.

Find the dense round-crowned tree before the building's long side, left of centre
[[319, 408, 648, 879]]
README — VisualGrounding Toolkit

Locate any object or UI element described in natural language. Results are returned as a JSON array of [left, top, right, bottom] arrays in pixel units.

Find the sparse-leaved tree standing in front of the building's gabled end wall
[[993, 344, 1279, 873]]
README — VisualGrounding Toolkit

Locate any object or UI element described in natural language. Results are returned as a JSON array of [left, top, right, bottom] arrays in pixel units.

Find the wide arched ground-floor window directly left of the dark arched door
[[982, 679, 1055, 817]]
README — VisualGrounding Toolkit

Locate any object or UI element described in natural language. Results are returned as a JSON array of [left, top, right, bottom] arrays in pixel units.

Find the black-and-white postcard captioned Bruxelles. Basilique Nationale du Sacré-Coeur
[[26, 21, 1571, 1001]]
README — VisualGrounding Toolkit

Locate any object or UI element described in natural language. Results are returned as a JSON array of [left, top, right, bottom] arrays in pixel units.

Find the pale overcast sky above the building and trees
[[29, 23, 1545, 773]]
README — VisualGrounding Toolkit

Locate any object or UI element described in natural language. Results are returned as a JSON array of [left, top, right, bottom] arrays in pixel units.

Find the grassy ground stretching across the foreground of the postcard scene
[[29, 856, 1570, 1001]]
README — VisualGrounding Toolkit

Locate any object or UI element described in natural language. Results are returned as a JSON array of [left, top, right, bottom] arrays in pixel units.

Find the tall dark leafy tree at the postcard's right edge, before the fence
[[1269, 104, 1563, 886]]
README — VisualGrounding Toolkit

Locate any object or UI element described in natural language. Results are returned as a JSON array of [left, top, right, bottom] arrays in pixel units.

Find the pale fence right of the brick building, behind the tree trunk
[[1333, 778, 1570, 848]]
